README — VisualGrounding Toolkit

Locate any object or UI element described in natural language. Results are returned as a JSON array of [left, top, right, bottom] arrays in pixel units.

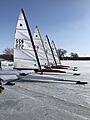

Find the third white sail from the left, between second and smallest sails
[[44, 37, 55, 64]]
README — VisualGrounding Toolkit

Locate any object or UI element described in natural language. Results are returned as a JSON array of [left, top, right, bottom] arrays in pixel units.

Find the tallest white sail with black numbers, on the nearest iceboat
[[14, 11, 38, 69]]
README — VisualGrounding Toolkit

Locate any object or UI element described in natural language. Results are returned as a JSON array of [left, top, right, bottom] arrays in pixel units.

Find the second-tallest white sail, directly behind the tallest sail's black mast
[[33, 26, 48, 66]]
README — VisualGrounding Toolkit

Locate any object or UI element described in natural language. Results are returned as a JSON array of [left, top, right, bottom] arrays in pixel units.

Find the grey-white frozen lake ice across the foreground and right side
[[0, 61, 90, 120]]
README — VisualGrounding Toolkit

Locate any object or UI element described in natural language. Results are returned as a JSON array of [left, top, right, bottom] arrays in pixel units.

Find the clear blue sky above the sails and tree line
[[0, 0, 90, 56]]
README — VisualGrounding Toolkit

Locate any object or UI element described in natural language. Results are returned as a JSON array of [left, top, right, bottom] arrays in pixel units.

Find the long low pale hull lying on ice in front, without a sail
[[2, 73, 87, 85]]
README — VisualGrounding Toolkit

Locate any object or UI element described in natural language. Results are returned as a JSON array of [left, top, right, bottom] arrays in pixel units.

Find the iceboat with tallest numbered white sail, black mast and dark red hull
[[14, 9, 66, 74]]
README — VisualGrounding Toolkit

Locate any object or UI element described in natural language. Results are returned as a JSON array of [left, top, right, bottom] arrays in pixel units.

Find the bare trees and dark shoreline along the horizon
[[0, 48, 90, 61]]
